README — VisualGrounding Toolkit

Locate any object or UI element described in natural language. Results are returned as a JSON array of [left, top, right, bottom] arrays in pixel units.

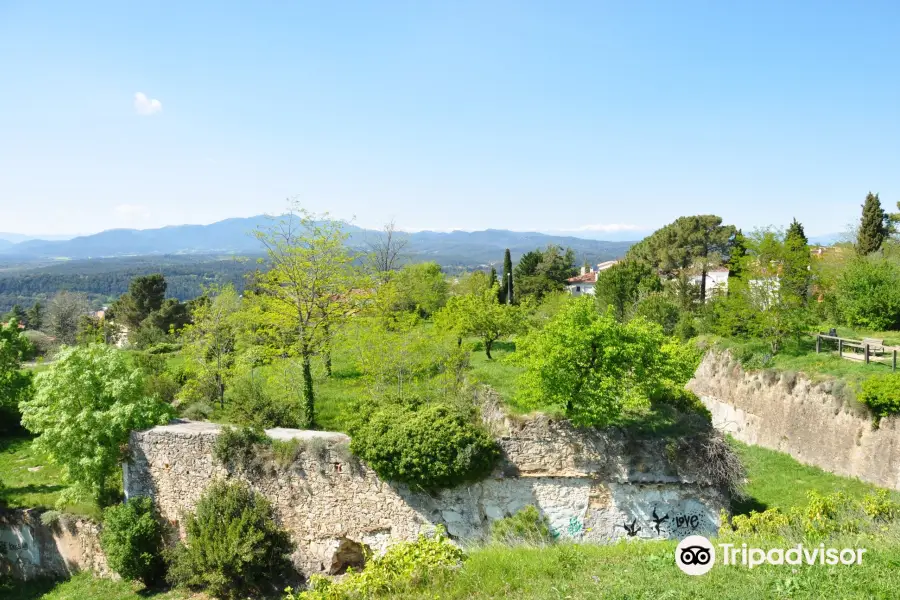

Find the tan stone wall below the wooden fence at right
[[688, 351, 900, 489]]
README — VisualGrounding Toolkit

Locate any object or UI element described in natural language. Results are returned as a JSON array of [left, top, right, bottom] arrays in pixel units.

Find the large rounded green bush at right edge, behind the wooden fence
[[837, 258, 900, 331]]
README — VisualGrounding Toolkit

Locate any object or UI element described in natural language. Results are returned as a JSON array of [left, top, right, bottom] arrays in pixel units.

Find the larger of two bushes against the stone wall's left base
[[168, 481, 294, 598]]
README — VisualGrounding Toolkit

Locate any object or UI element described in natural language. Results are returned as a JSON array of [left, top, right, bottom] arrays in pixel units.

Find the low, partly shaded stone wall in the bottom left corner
[[0, 510, 109, 580]]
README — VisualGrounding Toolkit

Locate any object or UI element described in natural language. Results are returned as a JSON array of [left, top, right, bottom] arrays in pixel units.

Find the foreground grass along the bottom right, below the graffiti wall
[[391, 542, 900, 600]]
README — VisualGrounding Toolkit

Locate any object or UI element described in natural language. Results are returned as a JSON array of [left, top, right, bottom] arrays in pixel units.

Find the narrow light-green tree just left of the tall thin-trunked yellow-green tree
[[181, 285, 241, 407]]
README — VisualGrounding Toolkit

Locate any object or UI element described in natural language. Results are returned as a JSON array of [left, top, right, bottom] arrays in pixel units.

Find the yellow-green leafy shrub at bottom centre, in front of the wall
[[283, 527, 466, 600]]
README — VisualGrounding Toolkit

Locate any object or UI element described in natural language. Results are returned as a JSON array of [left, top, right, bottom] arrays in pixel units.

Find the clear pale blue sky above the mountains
[[0, 0, 900, 237]]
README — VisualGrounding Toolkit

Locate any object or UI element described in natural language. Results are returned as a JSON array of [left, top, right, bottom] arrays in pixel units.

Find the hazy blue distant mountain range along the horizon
[[0, 215, 634, 266]]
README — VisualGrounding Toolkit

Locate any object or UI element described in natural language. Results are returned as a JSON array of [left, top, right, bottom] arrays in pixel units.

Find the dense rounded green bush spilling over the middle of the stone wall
[[350, 403, 499, 490]]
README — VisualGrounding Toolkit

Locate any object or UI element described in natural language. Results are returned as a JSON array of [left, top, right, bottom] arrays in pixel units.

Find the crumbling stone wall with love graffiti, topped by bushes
[[125, 415, 728, 574]]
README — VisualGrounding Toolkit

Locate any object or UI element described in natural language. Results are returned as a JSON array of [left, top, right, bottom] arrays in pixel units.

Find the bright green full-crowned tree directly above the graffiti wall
[[515, 296, 684, 426]]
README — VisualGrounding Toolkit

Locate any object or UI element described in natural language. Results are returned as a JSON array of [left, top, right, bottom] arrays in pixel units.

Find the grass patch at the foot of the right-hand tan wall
[[731, 440, 884, 514]]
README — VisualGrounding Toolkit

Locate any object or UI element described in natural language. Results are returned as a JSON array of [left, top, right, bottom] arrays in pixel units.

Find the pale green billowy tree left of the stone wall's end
[[20, 344, 172, 502]]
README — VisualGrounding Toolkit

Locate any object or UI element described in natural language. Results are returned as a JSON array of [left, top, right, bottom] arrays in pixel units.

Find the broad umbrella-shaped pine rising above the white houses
[[625, 215, 737, 302]]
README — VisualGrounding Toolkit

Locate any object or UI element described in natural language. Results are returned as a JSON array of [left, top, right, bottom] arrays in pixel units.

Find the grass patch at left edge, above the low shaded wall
[[0, 434, 99, 517]]
